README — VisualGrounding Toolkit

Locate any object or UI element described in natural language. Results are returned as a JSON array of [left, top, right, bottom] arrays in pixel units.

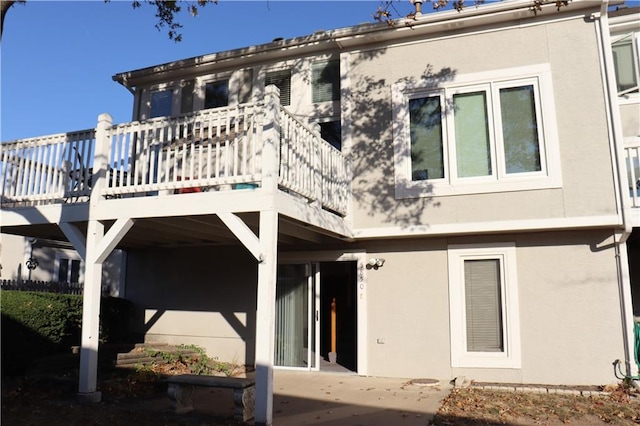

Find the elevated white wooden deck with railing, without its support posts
[[0, 91, 351, 247]]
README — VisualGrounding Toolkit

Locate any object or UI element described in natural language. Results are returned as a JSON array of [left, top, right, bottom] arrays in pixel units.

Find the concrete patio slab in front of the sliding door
[[164, 370, 452, 426]]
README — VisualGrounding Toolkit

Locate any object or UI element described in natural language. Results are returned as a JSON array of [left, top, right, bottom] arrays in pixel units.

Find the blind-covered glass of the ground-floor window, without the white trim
[[464, 259, 504, 352]]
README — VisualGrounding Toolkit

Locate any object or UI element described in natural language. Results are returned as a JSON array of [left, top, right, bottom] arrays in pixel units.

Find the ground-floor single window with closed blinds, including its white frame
[[447, 243, 521, 368]]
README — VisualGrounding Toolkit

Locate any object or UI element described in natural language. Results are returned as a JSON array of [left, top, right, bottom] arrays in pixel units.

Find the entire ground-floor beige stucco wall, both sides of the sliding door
[[127, 226, 624, 384]]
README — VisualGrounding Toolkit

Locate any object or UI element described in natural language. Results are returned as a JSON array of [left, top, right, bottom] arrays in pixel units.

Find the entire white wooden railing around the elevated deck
[[0, 90, 350, 215]]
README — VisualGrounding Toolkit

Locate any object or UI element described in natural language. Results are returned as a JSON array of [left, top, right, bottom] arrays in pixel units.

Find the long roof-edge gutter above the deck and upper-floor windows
[[112, 0, 608, 91]]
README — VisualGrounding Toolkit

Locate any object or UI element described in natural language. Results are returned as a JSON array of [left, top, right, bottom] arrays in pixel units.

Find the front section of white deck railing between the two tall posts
[[102, 104, 262, 196]]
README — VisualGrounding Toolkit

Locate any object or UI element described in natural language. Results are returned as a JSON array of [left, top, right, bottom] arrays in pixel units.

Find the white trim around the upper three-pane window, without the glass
[[391, 64, 562, 199]]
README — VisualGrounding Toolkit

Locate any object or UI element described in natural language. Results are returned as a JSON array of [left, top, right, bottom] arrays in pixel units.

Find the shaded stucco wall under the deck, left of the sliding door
[[126, 247, 257, 364]]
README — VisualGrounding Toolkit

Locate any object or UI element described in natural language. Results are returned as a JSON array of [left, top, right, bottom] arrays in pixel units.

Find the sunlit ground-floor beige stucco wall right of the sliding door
[[360, 232, 623, 384]]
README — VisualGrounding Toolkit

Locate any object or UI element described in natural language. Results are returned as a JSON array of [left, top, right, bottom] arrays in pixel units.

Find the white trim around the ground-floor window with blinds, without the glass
[[447, 243, 522, 369]]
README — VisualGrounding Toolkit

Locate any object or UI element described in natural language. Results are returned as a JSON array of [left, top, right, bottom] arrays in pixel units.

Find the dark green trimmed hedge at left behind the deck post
[[0, 290, 132, 373]]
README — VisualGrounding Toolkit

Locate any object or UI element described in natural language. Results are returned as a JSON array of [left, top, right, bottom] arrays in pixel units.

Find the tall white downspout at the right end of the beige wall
[[596, 0, 640, 389]]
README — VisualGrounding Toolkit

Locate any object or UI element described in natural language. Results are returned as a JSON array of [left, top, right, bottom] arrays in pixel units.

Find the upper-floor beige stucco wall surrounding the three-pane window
[[350, 15, 615, 228]]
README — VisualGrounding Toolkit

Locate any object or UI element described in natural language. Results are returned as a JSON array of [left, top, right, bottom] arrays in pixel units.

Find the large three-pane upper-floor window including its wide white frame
[[392, 65, 561, 198]]
